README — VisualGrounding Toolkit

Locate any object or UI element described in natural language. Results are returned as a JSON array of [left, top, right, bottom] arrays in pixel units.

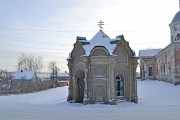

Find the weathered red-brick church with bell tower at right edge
[[139, 1, 180, 84]]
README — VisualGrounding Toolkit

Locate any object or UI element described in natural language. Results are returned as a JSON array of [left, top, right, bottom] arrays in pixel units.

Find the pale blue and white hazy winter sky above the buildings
[[0, 0, 179, 72]]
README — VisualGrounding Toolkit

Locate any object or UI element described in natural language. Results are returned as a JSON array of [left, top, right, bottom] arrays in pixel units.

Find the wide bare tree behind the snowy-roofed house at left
[[17, 54, 43, 71]]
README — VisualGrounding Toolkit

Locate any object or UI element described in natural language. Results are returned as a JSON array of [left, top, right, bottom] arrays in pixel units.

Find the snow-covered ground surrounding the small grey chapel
[[0, 80, 180, 120]]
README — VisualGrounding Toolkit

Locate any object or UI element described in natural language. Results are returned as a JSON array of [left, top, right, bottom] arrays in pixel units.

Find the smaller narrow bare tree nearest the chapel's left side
[[48, 61, 59, 79]]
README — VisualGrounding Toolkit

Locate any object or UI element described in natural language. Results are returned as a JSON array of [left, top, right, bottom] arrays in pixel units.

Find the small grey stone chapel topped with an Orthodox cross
[[67, 21, 138, 105]]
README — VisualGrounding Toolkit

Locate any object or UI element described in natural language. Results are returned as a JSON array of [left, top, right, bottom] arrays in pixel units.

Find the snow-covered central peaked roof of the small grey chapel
[[83, 30, 116, 56]]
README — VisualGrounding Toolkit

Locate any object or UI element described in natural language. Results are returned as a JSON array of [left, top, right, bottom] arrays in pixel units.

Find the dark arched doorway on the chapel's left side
[[76, 70, 85, 103]]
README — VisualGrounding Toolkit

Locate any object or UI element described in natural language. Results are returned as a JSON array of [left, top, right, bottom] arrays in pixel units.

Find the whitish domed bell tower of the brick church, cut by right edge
[[169, 0, 180, 43]]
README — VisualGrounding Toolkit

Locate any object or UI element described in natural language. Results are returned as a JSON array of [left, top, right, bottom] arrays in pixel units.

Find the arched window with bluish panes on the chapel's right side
[[115, 75, 124, 98]]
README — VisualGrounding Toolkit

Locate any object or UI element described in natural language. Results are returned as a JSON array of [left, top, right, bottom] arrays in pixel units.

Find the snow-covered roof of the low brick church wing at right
[[139, 49, 162, 57]]
